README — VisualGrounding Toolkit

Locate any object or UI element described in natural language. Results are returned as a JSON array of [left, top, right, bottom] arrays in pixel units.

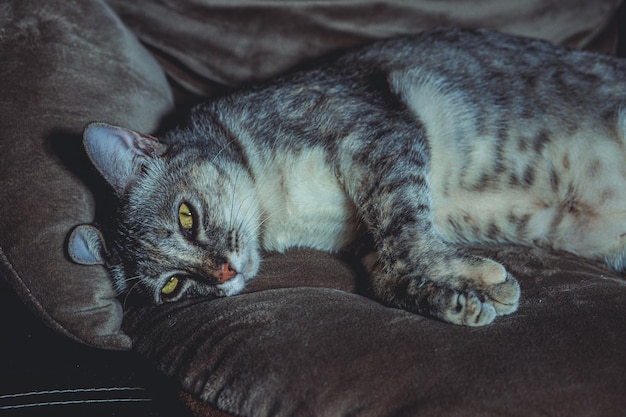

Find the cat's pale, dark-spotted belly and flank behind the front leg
[[399, 72, 626, 264]]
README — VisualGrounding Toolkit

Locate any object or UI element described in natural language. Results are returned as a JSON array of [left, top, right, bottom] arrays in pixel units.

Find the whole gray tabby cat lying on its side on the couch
[[69, 30, 626, 326]]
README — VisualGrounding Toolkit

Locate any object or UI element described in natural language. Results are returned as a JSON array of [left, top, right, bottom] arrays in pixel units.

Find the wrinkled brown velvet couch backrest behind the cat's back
[[109, 0, 621, 94]]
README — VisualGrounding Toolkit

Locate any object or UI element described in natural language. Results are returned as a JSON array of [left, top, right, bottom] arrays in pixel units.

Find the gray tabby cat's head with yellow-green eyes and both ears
[[68, 123, 260, 302]]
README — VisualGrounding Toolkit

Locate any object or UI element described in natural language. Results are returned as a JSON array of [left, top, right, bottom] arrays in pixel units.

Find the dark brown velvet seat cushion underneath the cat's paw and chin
[[125, 247, 626, 417]]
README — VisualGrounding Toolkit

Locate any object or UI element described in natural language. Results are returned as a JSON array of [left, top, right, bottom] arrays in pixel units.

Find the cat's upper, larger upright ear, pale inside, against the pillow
[[83, 122, 167, 195]]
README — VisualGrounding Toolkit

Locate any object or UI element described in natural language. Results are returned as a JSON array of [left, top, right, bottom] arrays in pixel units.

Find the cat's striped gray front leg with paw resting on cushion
[[339, 122, 520, 326]]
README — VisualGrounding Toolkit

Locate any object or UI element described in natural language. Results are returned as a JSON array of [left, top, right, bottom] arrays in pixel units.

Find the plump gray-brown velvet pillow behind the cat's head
[[0, 0, 172, 349]]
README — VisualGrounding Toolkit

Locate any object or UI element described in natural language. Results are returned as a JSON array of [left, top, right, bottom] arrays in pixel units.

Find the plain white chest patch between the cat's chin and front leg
[[252, 148, 356, 252]]
